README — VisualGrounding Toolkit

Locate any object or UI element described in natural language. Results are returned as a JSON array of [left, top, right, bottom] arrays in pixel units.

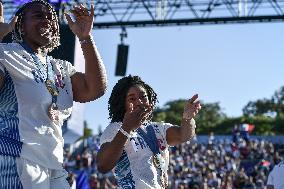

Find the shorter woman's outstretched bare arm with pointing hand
[[166, 94, 201, 146]]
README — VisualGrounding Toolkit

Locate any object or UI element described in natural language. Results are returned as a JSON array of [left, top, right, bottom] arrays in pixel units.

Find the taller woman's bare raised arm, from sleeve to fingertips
[[65, 5, 107, 102]]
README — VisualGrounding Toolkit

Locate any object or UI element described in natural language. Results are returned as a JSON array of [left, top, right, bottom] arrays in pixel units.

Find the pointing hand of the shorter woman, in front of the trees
[[182, 94, 201, 119]]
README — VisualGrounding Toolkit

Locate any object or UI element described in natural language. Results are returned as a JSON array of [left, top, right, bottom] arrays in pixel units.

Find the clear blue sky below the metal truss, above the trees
[[85, 23, 284, 132]]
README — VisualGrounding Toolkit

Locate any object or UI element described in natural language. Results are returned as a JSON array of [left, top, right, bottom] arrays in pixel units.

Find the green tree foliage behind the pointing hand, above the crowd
[[153, 87, 284, 135]]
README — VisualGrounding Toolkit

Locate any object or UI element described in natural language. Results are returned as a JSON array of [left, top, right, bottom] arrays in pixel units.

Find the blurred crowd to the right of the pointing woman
[[169, 137, 283, 189]]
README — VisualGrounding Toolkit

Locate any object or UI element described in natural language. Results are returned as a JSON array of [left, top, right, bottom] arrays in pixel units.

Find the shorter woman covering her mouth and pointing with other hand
[[97, 75, 201, 189]]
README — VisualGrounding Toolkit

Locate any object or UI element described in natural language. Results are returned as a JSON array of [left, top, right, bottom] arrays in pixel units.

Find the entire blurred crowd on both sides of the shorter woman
[[64, 133, 284, 189]]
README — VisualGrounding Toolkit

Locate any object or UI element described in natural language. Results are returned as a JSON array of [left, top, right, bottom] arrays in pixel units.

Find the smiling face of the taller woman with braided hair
[[22, 3, 56, 50]]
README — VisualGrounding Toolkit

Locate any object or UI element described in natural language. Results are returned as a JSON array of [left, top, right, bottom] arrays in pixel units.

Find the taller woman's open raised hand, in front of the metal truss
[[65, 4, 94, 40]]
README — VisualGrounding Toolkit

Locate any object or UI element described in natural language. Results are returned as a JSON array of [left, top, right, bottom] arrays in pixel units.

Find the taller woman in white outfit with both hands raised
[[0, 0, 107, 189]]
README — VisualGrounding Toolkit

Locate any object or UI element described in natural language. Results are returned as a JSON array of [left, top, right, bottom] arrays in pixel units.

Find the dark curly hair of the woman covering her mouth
[[108, 75, 158, 122]]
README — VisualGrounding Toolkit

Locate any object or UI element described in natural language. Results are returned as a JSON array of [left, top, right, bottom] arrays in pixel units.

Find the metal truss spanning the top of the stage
[[4, 0, 284, 29]]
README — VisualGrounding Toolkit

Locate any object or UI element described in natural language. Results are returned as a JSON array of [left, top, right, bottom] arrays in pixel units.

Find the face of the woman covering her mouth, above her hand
[[125, 85, 149, 111]]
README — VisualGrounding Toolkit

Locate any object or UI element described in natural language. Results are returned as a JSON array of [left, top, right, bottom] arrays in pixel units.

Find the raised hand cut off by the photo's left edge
[[0, 2, 17, 39]]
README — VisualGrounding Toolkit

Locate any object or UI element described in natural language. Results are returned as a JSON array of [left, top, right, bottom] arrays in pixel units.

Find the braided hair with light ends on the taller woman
[[12, 0, 60, 53]]
